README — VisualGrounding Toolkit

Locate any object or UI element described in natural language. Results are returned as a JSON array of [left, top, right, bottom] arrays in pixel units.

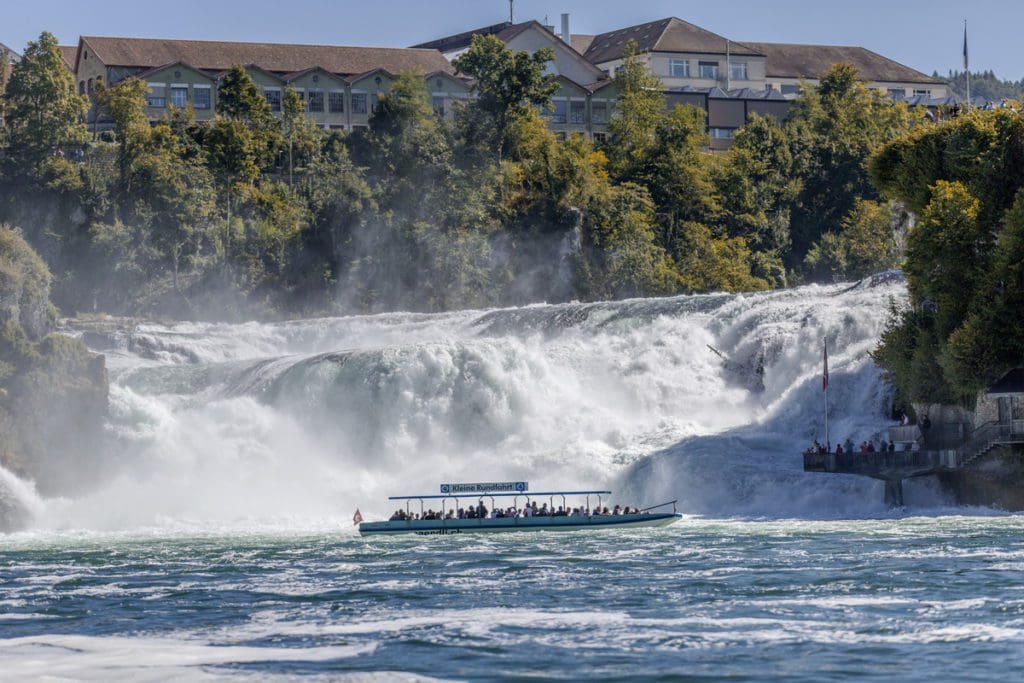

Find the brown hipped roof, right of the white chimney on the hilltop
[[584, 16, 760, 63]]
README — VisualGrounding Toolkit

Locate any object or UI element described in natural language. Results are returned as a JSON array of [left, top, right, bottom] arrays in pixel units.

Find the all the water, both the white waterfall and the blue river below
[[0, 275, 1024, 681]]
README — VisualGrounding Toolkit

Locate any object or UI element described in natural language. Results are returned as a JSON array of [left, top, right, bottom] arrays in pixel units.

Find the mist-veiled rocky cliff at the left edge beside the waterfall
[[0, 226, 109, 529]]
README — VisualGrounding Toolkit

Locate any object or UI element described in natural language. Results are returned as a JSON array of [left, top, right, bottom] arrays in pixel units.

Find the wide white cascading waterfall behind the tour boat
[[6, 275, 921, 529]]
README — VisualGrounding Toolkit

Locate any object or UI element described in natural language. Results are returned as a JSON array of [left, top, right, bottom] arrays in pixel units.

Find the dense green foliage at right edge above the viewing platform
[[870, 110, 1024, 401]]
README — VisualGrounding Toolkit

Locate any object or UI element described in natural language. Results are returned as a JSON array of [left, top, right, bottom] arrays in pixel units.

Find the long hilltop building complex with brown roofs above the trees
[[41, 14, 953, 150]]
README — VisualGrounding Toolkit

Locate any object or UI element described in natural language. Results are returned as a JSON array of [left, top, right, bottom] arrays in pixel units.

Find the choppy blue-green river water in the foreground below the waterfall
[[0, 514, 1024, 681]]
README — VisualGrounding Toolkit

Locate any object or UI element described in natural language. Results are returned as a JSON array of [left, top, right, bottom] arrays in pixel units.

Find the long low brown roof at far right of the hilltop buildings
[[743, 43, 943, 84]]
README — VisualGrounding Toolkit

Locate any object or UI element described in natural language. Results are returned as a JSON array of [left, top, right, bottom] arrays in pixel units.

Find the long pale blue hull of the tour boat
[[359, 512, 682, 536]]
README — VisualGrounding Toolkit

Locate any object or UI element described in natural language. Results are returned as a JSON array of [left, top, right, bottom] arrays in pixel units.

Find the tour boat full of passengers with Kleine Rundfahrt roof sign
[[355, 481, 682, 536]]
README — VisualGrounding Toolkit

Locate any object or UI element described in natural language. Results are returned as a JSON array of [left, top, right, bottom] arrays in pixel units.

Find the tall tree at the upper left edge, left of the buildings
[[4, 32, 88, 177]]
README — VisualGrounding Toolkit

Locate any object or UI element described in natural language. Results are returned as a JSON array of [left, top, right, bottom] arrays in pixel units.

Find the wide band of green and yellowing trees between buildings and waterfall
[[0, 34, 923, 319]]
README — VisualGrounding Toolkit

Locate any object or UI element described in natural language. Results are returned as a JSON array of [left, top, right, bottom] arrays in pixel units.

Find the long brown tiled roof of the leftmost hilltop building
[[82, 36, 452, 76]]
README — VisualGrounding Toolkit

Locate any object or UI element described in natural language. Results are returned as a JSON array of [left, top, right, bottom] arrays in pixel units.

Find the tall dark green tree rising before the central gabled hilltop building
[[452, 36, 558, 158]]
